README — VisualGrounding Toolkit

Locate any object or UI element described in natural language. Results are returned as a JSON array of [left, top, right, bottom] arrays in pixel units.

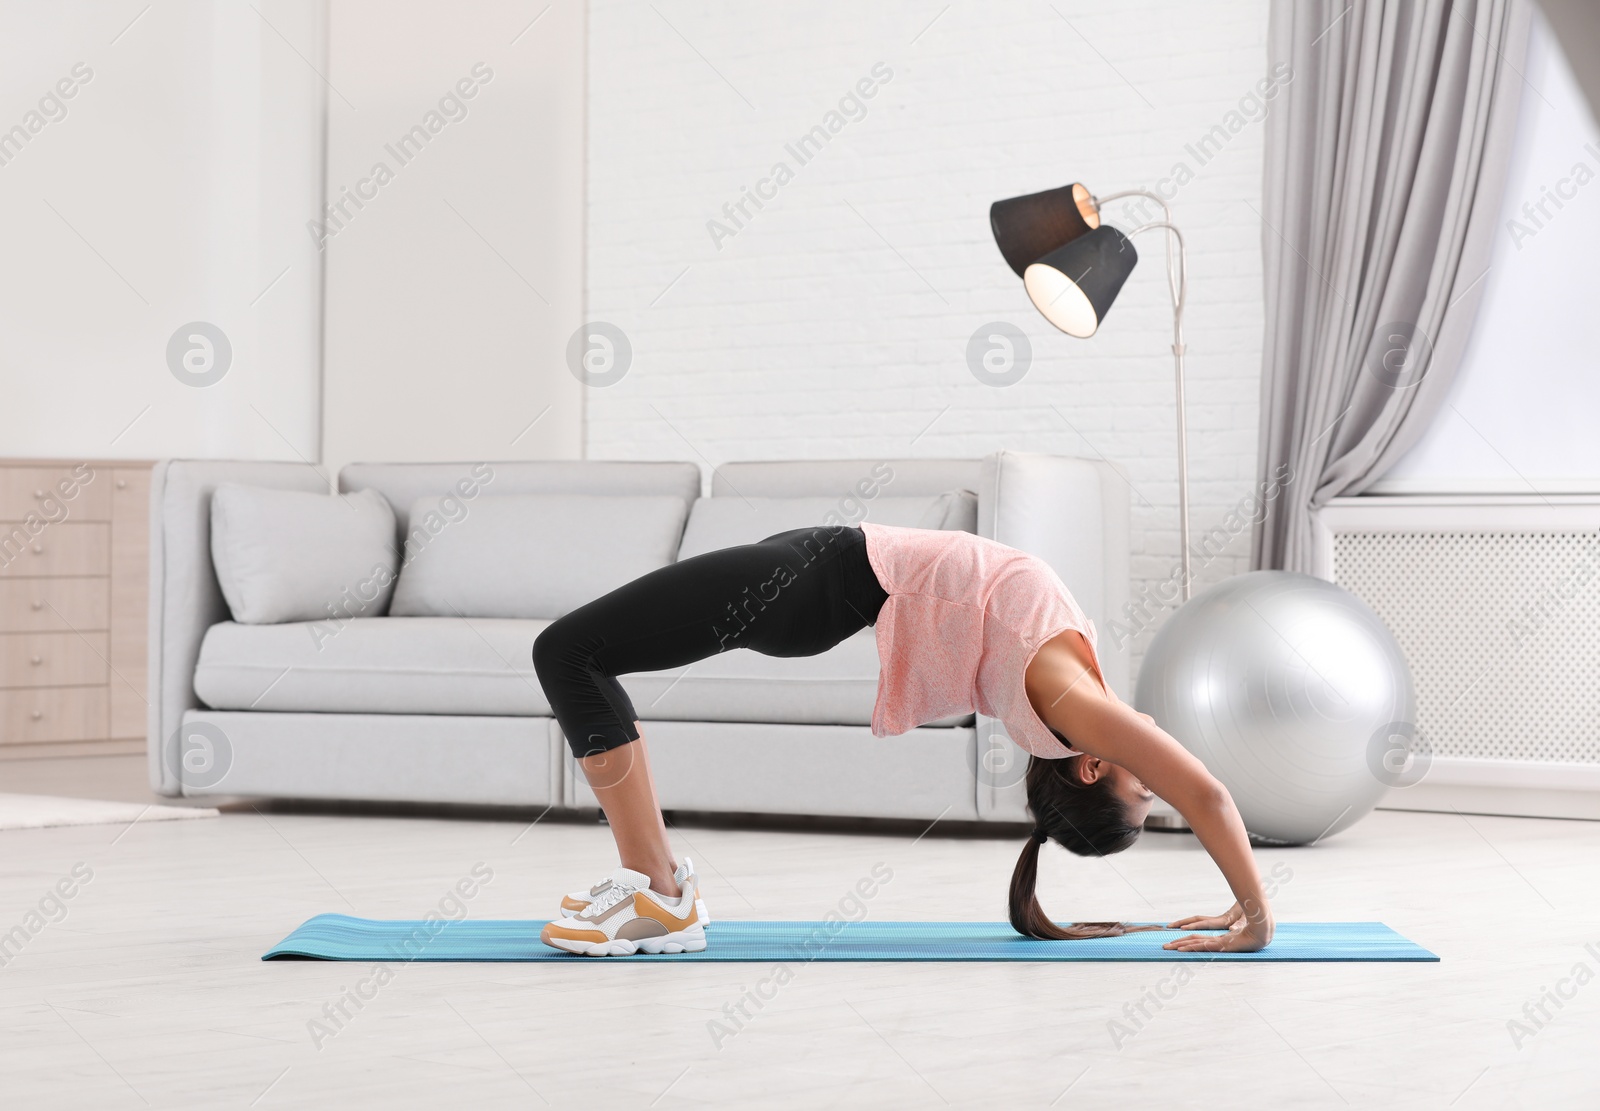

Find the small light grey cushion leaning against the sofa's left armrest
[[211, 482, 400, 624]]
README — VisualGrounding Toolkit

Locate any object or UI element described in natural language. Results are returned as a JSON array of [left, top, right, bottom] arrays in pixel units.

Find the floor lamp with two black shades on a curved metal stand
[[989, 182, 1190, 602]]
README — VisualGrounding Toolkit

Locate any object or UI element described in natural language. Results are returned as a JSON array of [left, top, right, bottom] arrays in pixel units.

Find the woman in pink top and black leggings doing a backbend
[[533, 522, 1274, 956]]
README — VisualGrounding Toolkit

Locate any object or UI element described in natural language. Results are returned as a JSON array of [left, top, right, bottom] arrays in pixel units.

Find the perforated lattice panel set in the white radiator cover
[[1333, 530, 1600, 764]]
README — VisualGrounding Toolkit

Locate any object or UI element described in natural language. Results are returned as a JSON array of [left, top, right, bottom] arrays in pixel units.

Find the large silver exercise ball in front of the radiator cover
[[1134, 572, 1414, 845]]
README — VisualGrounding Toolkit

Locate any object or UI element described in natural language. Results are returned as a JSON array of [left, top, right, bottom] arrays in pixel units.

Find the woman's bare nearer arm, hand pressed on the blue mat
[[1026, 632, 1274, 951]]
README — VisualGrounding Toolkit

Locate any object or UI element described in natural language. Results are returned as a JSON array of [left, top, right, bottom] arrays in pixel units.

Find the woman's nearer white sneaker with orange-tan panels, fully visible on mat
[[539, 868, 706, 957]]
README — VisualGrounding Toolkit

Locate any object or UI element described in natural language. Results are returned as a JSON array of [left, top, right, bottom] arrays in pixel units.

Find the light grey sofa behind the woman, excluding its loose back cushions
[[149, 451, 1128, 821]]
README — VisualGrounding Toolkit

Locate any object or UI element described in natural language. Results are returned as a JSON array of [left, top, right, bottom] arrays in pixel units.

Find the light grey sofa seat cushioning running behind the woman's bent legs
[[195, 618, 970, 725]]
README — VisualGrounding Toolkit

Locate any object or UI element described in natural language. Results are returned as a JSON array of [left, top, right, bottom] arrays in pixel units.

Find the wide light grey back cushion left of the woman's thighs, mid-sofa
[[389, 495, 685, 620]]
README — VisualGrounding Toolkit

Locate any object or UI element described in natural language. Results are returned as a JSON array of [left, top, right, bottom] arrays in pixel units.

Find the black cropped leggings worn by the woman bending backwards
[[533, 525, 888, 757]]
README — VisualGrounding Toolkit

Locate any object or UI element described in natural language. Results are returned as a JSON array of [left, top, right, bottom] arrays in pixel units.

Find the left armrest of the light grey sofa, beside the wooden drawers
[[146, 459, 328, 796]]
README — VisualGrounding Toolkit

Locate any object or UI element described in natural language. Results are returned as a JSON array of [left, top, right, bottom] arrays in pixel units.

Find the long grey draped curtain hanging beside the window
[[1251, 0, 1531, 572]]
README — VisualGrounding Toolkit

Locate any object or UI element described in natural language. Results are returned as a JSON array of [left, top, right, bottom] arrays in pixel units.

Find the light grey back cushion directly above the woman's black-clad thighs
[[678, 490, 978, 560]]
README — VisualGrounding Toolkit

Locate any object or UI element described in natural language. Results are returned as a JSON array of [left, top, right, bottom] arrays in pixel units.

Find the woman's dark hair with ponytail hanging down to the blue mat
[[1010, 756, 1158, 941]]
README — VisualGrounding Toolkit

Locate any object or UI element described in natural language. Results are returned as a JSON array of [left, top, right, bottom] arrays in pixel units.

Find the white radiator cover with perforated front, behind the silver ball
[[1312, 495, 1600, 818]]
